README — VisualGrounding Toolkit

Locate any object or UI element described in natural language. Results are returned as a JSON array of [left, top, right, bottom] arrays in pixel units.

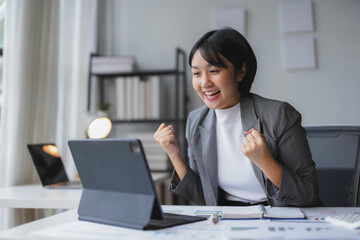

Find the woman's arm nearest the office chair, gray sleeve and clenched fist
[[243, 103, 320, 206]]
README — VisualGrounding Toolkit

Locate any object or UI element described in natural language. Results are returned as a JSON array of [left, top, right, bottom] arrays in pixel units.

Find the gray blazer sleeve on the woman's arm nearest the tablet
[[169, 113, 205, 205]]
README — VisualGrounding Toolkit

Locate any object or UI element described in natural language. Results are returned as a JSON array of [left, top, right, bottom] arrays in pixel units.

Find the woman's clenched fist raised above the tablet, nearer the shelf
[[154, 123, 180, 157]]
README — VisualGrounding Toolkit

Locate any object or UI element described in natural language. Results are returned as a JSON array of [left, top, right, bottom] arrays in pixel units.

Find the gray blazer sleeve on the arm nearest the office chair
[[266, 103, 319, 207]]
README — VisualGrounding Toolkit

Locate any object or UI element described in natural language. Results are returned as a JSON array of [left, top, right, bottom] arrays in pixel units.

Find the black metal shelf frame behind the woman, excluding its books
[[87, 48, 189, 170]]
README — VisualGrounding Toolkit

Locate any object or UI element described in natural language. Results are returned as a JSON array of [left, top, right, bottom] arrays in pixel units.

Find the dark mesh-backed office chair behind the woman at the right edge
[[305, 126, 360, 207]]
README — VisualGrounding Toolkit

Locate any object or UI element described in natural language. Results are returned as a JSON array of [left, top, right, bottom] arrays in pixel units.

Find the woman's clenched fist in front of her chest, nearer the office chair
[[241, 128, 272, 167]]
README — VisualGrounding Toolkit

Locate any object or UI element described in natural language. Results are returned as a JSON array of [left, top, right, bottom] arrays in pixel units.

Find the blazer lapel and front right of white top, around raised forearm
[[240, 96, 266, 192]]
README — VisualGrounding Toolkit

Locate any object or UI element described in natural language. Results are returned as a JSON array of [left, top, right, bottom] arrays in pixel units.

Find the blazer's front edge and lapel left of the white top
[[199, 110, 218, 205]]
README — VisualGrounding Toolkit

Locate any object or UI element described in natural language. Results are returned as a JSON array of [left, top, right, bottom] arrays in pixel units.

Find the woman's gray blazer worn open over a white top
[[169, 94, 321, 207]]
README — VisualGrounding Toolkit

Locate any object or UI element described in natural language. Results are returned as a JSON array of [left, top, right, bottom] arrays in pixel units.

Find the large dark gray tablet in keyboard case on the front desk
[[68, 139, 206, 230]]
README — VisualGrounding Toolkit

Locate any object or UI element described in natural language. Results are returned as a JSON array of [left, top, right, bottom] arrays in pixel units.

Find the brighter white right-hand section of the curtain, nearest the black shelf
[[56, 0, 97, 178]]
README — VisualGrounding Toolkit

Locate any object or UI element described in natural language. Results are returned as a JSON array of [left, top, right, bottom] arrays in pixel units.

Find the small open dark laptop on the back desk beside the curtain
[[27, 143, 82, 189]]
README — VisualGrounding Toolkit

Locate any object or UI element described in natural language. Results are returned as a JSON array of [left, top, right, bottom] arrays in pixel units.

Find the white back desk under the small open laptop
[[0, 173, 169, 209]]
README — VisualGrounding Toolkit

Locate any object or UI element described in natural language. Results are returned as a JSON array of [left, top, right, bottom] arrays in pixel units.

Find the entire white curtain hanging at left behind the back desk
[[0, 0, 96, 230]]
